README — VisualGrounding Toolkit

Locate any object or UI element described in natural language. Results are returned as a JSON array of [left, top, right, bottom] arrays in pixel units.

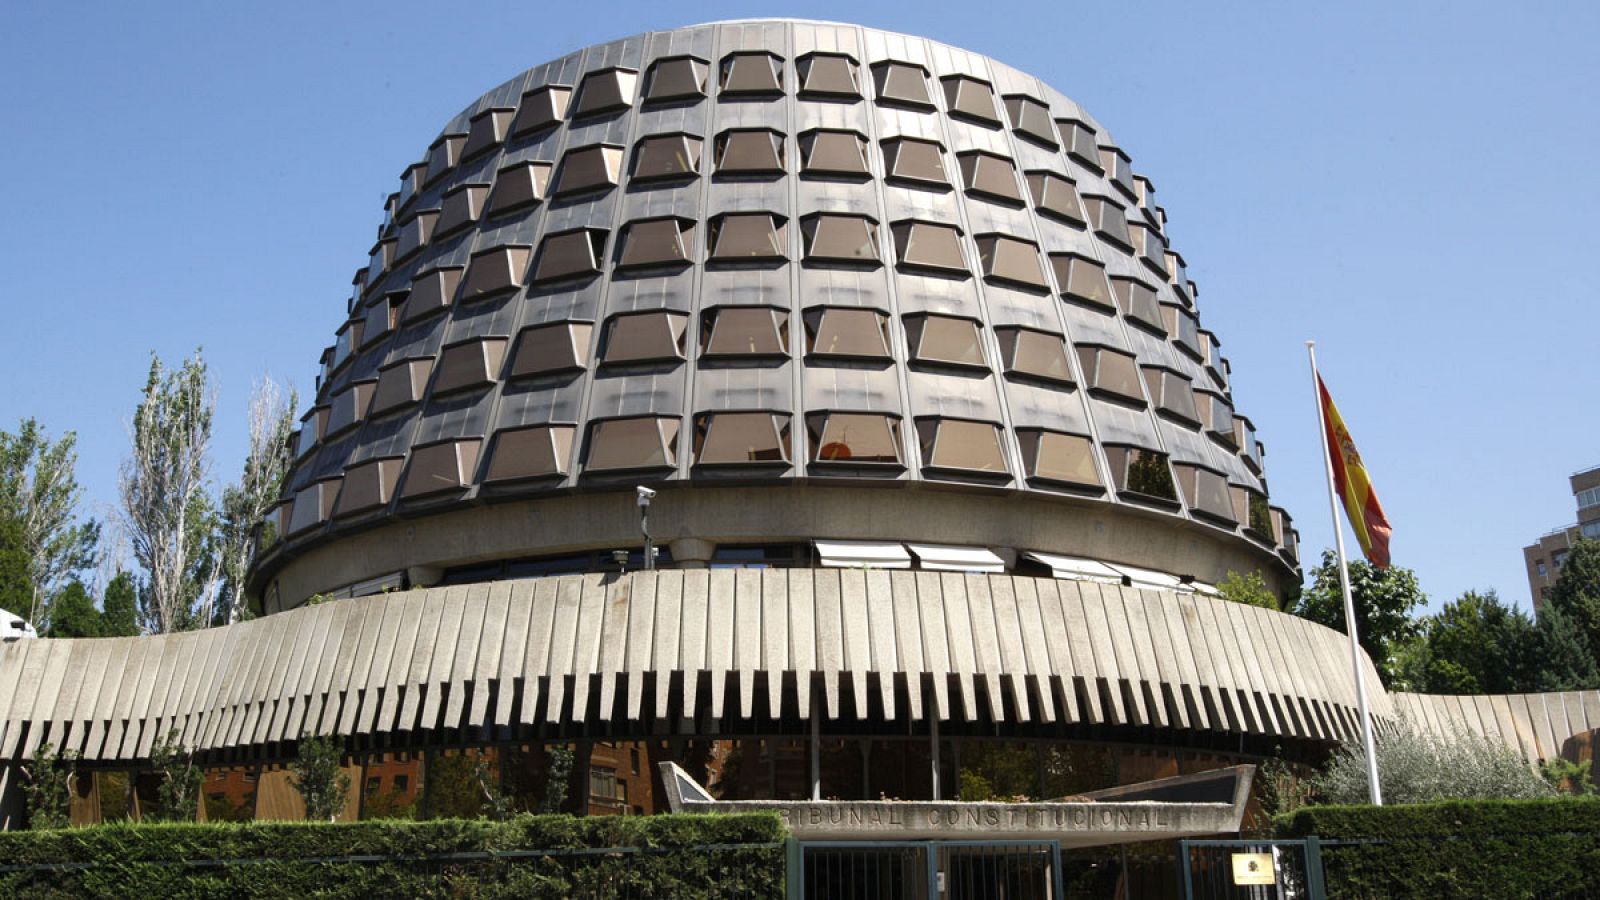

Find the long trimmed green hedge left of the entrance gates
[[0, 814, 786, 900]]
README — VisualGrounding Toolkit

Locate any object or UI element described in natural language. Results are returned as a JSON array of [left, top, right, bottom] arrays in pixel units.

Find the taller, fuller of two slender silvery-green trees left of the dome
[[120, 351, 219, 633]]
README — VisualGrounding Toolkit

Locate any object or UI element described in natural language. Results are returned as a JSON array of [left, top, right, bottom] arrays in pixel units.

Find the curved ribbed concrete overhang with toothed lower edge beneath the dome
[[0, 569, 1395, 761]]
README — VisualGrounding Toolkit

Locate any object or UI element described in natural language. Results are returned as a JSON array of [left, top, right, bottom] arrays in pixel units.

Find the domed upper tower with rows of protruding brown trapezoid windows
[[253, 21, 1296, 612]]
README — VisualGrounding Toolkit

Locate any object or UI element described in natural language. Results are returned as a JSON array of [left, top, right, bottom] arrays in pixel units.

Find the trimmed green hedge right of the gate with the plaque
[[1277, 798, 1600, 900]]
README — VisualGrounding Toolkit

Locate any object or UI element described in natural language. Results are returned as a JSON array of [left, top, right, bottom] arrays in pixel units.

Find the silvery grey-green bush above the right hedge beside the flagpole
[[1312, 721, 1554, 804]]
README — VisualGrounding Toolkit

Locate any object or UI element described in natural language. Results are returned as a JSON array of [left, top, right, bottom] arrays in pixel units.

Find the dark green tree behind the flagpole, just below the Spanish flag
[[1291, 549, 1427, 685]]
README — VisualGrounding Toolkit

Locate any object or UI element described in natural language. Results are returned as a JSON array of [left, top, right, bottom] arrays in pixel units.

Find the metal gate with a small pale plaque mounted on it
[[1178, 838, 1328, 900]]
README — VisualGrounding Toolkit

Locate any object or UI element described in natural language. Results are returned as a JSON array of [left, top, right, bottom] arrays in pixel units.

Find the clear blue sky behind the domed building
[[0, 0, 1600, 605]]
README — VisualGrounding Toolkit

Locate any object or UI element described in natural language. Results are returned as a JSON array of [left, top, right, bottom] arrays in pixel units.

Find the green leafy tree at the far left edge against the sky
[[0, 418, 99, 631]]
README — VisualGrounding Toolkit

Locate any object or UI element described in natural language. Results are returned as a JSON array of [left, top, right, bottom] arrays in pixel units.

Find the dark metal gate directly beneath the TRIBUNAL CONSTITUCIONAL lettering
[[789, 841, 1066, 900]]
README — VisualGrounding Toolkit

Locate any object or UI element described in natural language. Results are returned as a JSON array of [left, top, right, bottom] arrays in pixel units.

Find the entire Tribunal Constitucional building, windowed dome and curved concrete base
[[0, 21, 1600, 864]]
